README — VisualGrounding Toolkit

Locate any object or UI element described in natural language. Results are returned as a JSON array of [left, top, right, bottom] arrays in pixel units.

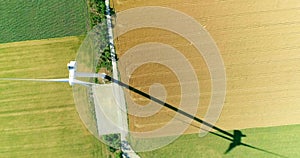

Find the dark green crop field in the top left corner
[[0, 0, 89, 43]]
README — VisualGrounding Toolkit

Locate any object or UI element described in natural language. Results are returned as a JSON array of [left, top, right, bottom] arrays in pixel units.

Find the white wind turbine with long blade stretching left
[[0, 61, 106, 86]]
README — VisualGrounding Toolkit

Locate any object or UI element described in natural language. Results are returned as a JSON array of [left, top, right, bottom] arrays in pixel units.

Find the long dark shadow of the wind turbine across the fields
[[104, 75, 285, 157]]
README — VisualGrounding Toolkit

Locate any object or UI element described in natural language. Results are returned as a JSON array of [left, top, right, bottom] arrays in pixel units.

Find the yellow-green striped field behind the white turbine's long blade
[[0, 37, 109, 158]]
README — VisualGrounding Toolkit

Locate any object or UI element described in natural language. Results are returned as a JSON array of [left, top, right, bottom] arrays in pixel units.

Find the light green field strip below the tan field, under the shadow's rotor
[[139, 125, 300, 158]]
